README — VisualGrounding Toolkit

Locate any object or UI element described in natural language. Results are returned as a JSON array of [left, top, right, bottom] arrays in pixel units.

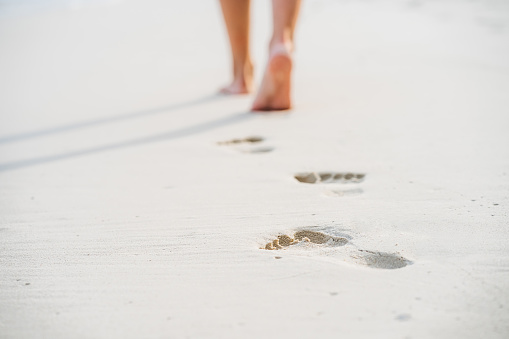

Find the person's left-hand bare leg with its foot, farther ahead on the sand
[[220, 0, 253, 94]]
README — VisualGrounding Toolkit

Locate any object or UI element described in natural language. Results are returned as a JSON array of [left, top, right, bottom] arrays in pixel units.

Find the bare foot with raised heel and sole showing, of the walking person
[[251, 43, 292, 111]]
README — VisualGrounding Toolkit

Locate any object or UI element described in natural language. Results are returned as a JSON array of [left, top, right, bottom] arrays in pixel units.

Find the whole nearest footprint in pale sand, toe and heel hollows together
[[261, 230, 412, 269]]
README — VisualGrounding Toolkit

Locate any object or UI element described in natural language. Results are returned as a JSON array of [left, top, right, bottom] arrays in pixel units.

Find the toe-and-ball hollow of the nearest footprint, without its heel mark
[[263, 230, 348, 250]]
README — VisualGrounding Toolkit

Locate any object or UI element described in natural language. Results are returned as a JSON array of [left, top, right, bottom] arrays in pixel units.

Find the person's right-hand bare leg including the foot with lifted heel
[[252, 0, 301, 111]]
